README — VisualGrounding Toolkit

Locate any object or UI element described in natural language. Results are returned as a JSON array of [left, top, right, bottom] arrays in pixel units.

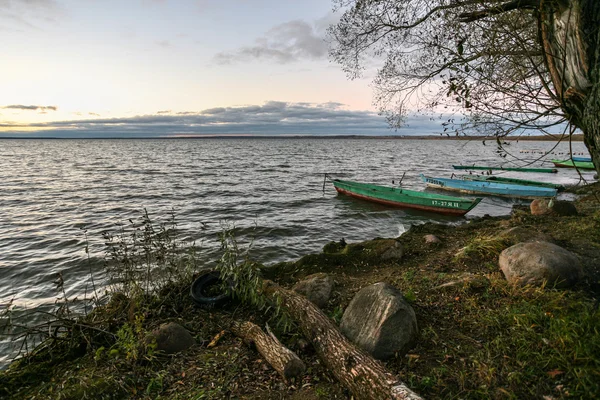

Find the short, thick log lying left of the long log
[[231, 321, 306, 379]]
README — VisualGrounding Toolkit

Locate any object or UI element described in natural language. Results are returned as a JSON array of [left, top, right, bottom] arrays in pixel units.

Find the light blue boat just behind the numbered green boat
[[421, 174, 557, 199]]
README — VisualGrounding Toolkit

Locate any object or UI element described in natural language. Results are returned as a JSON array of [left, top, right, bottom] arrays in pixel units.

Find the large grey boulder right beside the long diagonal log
[[340, 282, 418, 360]]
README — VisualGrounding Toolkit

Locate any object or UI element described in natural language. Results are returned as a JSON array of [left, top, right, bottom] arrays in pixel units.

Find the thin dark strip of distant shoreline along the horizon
[[0, 134, 583, 142]]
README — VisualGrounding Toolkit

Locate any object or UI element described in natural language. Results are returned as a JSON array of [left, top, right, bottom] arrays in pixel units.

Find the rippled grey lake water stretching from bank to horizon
[[0, 138, 593, 364]]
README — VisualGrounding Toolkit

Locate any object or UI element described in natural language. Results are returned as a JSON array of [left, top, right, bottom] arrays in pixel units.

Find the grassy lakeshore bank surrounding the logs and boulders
[[0, 185, 600, 399]]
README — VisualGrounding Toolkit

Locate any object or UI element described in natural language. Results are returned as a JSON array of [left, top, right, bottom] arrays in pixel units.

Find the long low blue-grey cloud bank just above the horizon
[[0, 101, 404, 137]]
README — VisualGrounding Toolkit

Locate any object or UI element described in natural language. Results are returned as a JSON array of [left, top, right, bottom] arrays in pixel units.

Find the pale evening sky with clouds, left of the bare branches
[[0, 0, 440, 137]]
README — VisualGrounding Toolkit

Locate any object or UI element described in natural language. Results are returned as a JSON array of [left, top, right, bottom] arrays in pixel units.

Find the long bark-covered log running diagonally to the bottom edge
[[262, 280, 421, 400]]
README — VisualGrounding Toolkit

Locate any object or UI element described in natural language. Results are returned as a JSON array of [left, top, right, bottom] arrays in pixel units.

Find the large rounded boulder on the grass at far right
[[499, 242, 583, 287]]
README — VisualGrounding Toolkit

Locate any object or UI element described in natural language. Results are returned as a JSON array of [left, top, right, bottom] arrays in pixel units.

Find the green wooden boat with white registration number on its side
[[333, 179, 481, 215]]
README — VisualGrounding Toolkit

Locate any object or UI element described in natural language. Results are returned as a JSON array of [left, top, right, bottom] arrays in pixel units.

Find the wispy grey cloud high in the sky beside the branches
[[213, 16, 333, 65]]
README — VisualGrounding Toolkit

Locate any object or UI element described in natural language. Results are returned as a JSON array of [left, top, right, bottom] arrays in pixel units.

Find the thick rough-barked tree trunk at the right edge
[[540, 0, 600, 173]]
